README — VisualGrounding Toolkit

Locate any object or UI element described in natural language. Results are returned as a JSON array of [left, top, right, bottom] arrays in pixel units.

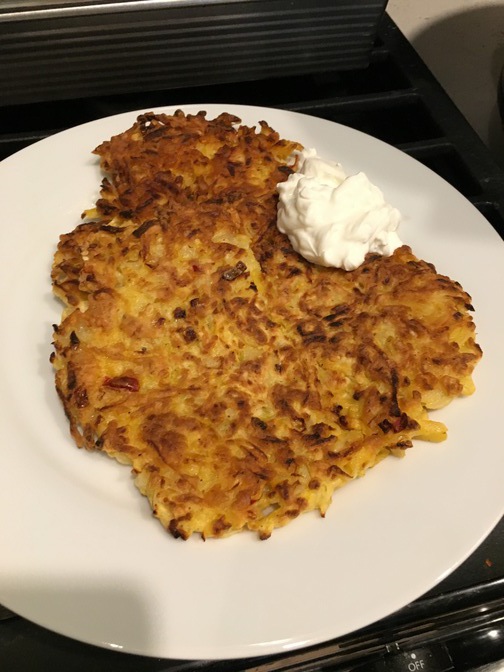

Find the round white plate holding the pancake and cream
[[0, 105, 504, 659]]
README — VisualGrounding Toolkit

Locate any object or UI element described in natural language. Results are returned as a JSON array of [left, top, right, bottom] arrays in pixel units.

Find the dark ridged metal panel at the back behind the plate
[[0, 0, 386, 105]]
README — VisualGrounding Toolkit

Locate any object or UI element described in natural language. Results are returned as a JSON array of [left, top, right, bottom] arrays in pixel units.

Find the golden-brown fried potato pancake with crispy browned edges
[[51, 111, 481, 539]]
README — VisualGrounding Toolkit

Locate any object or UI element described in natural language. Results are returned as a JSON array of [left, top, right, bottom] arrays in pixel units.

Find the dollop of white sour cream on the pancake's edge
[[277, 149, 402, 271]]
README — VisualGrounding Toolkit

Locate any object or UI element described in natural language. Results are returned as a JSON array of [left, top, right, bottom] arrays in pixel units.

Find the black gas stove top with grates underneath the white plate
[[0, 10, 504, 672]]
